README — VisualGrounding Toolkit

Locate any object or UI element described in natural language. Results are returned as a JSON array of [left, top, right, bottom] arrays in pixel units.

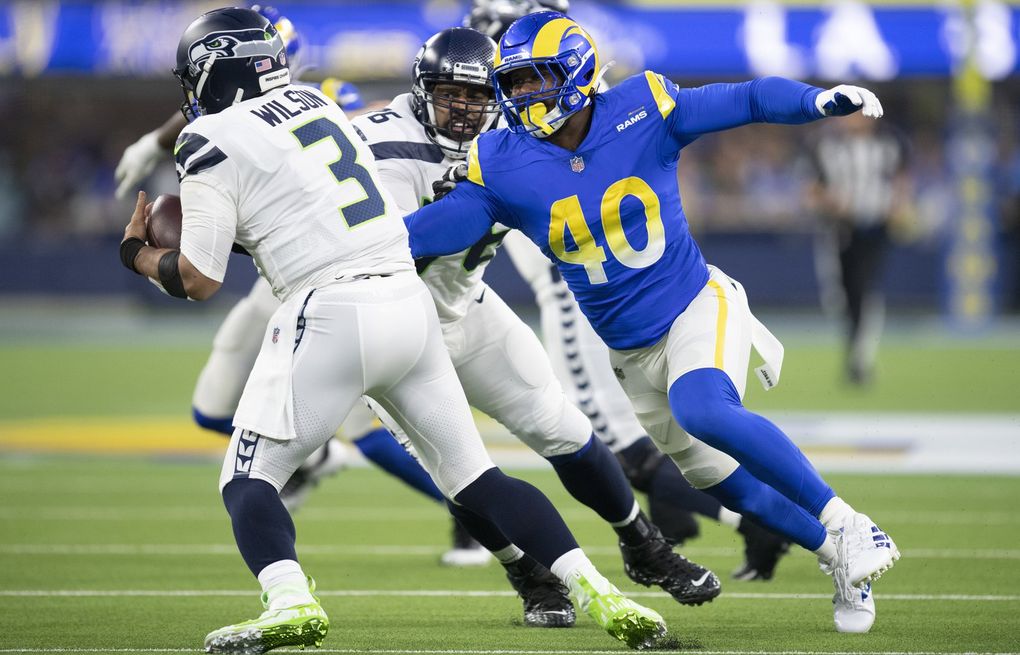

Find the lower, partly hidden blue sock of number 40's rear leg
[[703, 466, 825, 551]]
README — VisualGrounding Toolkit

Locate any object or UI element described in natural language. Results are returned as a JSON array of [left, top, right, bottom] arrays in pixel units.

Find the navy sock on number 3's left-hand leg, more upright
[[223, 477, 298, 575]]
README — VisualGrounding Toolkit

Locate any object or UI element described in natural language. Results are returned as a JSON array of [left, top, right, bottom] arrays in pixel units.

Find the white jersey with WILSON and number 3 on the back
[[174, 85, 413, 300]]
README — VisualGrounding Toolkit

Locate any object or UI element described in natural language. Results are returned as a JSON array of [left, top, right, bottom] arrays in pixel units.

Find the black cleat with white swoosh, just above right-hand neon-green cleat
[[620, 514, 722, 605]]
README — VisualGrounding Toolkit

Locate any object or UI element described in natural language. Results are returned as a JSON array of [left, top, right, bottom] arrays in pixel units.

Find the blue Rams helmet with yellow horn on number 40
[[493, 11, 599, 139]]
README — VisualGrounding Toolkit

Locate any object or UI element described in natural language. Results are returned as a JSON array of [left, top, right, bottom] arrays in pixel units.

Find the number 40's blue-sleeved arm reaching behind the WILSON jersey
[[404, 183, 507, 259]]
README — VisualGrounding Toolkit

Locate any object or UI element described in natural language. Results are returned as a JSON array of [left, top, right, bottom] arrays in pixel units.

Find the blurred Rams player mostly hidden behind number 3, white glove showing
[[116, 5, 491, 566]]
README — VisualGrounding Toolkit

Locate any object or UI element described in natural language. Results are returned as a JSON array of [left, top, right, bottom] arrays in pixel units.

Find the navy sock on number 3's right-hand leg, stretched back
[[454, 466, 577, 568]]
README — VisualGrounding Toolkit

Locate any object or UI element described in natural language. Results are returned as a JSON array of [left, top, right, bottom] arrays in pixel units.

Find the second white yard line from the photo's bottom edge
[[0, 589, 1020, 599]]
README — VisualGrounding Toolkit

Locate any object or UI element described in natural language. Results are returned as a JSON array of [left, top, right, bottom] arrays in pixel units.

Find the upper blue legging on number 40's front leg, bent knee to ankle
[[669, 368, 835, 516]]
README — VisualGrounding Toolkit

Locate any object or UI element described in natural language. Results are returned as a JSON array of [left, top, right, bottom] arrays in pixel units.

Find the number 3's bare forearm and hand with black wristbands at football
[[120, 191, 220, 300]]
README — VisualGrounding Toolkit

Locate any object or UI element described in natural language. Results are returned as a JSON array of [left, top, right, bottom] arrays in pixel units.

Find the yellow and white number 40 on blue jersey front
[[549, 178, 666, 285]]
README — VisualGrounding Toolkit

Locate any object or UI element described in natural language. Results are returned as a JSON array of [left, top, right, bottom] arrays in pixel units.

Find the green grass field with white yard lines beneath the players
[[0, 316, 1020, 655]]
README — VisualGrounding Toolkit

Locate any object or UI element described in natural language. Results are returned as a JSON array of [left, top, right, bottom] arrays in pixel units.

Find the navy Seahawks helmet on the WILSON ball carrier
[[173, 7, 291, 119]]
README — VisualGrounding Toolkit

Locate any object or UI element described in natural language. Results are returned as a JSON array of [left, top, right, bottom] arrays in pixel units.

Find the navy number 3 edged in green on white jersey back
[[291, 117, 386, 228]]
